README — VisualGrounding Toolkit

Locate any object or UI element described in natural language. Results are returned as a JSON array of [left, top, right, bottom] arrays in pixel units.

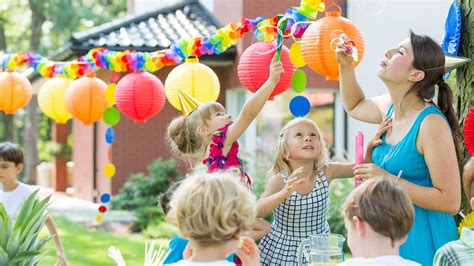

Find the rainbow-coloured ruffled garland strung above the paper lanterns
[[0, 0, 325, 79]]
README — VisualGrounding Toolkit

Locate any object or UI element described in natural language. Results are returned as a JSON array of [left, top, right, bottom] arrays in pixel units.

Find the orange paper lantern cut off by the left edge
[[0, 71, 33, 115]]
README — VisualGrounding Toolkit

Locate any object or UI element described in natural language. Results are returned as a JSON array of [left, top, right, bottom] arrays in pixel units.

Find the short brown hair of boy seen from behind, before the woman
[[342, 178, 414, 245]]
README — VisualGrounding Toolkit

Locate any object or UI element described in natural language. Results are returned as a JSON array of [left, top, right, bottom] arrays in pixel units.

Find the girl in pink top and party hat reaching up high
[[168, 54, 283, 240]]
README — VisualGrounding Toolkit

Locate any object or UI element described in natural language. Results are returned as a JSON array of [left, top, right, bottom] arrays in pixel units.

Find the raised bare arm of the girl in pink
[[224, 53, 284, 147]]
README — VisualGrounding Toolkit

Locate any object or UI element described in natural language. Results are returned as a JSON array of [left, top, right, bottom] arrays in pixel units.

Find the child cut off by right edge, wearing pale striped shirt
[[433, 157, 474, 266]]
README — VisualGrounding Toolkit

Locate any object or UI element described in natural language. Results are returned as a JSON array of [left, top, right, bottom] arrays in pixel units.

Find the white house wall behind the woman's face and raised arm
[[347, 0, 452, 158]]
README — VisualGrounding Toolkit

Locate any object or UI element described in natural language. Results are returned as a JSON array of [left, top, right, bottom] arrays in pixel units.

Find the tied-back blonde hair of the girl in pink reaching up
[[167, 102, 225, 164]]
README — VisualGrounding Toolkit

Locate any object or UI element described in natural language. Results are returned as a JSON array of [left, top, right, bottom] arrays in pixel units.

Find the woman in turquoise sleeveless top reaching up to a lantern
[[336, 32, 461, 265]]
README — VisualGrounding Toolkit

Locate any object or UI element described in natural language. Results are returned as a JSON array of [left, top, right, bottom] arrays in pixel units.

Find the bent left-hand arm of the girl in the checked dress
[[257, 167, 304, 218]]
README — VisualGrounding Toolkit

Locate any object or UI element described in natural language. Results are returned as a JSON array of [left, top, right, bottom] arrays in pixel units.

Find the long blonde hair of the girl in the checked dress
[[270, 117, 329, 174]]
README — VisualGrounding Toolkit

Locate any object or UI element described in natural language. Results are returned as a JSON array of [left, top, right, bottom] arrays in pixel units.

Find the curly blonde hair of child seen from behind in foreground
[[167, 172, 257, 247]]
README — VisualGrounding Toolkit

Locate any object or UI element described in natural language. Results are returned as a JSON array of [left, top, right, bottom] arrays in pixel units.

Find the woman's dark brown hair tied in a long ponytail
[[407, 31, 459, 159]]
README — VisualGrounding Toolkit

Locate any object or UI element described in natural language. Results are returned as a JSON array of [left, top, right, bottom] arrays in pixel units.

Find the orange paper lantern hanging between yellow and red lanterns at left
[[66, 75, 107, 125]]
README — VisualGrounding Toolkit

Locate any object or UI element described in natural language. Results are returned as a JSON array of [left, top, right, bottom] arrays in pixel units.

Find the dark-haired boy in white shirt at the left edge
[[0, 142, 67, 266]]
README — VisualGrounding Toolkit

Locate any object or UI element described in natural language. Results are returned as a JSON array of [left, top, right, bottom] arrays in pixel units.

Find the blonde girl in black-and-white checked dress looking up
[[257, 118, 354, 265]]
